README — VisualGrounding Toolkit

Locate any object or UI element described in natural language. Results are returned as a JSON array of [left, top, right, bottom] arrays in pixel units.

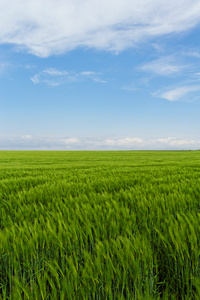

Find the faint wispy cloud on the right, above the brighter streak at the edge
[[140, 57, 187, 76]]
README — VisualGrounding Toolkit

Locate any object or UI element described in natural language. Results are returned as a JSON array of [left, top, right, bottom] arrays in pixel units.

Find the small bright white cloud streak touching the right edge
[[153, 85, 200, 101]]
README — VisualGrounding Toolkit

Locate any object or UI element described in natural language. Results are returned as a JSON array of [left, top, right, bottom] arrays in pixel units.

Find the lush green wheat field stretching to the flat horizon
[[0, 151, 200, 300]]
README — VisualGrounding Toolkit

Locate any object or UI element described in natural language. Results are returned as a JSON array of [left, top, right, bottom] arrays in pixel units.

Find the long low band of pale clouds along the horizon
[[0, 134, 200, 150]]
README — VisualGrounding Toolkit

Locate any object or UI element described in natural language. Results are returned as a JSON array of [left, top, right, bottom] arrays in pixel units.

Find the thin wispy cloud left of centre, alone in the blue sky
[[31, 68, 106, 86]]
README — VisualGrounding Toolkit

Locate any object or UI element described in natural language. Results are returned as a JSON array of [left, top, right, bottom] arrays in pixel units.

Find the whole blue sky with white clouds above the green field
[[0, 0, 200, 150]]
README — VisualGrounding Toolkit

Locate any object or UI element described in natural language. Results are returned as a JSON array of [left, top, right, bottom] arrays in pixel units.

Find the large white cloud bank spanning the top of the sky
[[0, 0, 200, 57]]
